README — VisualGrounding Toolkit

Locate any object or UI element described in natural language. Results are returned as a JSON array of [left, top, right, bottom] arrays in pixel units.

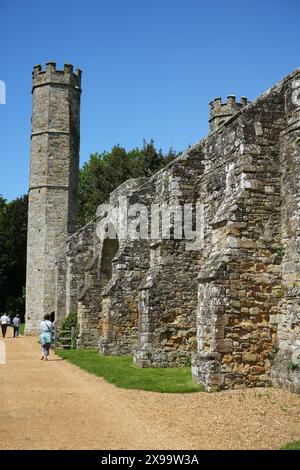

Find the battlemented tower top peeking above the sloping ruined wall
[[209, 95, 250, 131]]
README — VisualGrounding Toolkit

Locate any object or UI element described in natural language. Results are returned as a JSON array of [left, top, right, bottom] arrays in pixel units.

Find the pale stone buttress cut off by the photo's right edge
[[271, 71, 300, 393]]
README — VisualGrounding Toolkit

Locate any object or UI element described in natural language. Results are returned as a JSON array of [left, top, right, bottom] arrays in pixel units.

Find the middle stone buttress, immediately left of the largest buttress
[[134, 149, 203, 367]]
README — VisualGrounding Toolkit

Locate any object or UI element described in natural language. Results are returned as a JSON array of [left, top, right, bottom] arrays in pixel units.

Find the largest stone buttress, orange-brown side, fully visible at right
[[192, 73, 287, 390]]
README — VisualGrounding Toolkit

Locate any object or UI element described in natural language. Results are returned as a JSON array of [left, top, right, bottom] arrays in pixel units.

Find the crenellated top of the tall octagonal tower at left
[[32, 62, 82, 90]]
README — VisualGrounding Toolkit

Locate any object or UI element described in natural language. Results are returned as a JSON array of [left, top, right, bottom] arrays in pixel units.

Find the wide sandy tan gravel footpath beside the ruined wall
[[0, 337, 300, 450]]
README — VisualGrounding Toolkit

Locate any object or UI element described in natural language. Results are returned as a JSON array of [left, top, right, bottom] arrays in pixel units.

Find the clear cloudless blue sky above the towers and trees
[[0, 0, 300, 200]]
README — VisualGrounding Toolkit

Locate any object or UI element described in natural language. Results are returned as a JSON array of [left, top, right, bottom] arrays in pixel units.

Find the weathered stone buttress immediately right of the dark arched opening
[[99, 178, 151, 355]]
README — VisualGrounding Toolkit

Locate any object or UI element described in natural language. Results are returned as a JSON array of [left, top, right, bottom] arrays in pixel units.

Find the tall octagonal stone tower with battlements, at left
[[26, 62, 81, 334]]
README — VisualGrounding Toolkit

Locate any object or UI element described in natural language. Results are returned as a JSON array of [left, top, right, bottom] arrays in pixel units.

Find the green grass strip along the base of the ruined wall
[[56, 349, 203, 393]]
